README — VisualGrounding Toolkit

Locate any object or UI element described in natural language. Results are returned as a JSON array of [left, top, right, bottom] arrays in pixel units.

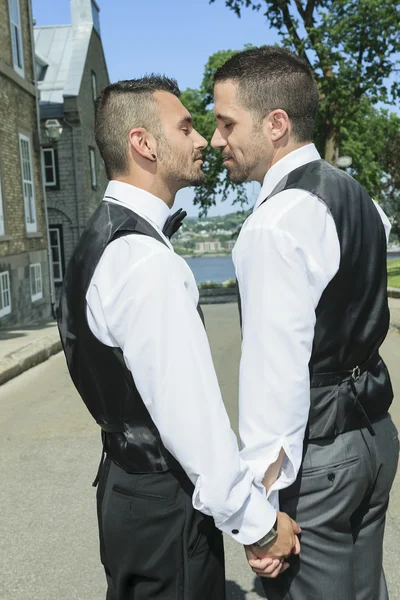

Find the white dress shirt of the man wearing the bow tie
[[86, 181, 276, 544]]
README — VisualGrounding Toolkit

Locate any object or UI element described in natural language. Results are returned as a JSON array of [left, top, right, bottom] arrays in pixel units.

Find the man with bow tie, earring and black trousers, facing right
[[59, 75, 299, 600]]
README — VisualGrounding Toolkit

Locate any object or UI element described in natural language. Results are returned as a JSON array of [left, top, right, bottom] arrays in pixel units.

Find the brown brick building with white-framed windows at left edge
[[0, 0, 52, 329]]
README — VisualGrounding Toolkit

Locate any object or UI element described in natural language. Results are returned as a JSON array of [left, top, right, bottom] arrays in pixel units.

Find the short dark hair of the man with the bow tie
[[94, 74, 180, 179]]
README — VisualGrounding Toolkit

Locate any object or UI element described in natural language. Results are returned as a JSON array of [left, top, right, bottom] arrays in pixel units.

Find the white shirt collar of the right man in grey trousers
[[254, 144, 321, 210]]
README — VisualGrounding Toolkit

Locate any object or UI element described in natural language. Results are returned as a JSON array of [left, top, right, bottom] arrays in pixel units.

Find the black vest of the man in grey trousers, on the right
[[242, 160, 393, 440]]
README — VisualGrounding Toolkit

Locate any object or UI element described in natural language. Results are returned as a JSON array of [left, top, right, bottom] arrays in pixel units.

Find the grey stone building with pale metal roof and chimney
[[35, 0, 109, 296]]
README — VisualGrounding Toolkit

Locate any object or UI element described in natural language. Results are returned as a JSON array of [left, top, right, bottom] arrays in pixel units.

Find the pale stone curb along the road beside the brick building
[[0, 336, 62, 385]]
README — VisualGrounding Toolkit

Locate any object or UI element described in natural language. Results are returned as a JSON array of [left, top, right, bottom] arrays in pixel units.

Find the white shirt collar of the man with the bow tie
[[104, 180, 171, 231]]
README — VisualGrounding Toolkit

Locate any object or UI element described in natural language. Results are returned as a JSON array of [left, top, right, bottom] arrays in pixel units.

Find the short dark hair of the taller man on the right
[[214, 46, 319, 142]]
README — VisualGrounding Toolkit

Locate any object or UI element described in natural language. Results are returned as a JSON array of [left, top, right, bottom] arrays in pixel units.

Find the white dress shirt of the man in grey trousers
[[233, 144, 390, 509]]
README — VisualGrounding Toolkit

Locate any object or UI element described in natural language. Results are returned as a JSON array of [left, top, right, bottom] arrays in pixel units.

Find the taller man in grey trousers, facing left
[[211, 46, 399, 600]]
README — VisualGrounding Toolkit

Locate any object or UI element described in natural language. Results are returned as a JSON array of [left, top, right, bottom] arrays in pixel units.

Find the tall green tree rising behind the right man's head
[[209, 0, 400, 163]]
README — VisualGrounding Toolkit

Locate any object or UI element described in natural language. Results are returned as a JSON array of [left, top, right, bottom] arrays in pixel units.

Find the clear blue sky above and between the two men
[[33, 0, 278, 216]]
